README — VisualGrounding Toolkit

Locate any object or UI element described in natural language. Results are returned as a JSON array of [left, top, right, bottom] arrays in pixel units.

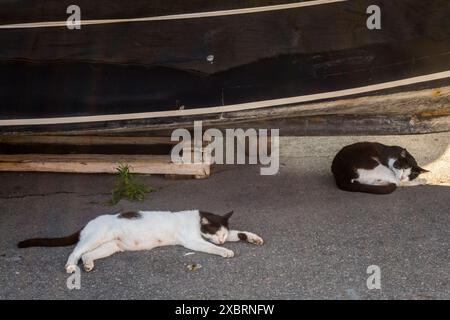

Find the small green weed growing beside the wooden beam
[[108, 164, 157, 205]]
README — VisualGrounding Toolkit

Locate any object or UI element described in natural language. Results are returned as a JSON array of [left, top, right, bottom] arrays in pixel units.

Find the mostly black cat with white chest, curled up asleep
[[331, 142, 428, 194]]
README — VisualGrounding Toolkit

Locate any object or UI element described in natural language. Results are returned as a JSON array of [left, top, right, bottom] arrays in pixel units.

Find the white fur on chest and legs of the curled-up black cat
[[352, 158, 426, 187]]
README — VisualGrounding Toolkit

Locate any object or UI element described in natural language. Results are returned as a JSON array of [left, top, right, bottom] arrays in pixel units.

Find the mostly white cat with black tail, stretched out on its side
[[18, 210, 263, 273]]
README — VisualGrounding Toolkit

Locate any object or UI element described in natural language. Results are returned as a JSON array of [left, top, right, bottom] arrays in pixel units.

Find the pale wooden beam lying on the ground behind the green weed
[[0, 154, 210, 177]]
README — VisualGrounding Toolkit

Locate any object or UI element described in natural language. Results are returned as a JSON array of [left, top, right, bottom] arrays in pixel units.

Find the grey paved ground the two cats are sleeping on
[[0, 133, 450, 299]]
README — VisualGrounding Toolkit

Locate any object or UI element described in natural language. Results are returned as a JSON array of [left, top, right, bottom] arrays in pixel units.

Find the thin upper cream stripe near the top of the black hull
[[0, 0, 347, 29]]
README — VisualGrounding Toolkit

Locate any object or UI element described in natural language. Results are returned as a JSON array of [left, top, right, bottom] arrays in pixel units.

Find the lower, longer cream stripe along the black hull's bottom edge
[[0, 70, 450, 127]]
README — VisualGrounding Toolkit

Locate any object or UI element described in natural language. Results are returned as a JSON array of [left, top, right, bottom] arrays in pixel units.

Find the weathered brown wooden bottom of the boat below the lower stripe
[[0, 79, 450, 136]]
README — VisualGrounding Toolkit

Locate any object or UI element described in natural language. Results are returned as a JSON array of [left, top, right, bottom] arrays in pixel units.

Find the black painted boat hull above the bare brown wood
[[0, 0, 450, 132]]
